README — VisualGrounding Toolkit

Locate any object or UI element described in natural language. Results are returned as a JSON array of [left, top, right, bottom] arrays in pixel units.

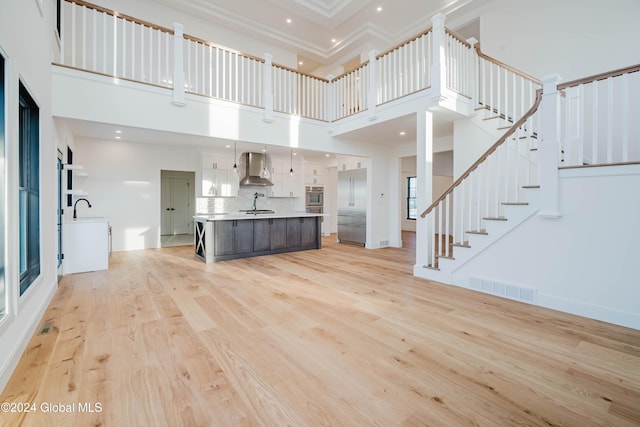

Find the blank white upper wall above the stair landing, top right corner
[[480, 0, 640, 81]]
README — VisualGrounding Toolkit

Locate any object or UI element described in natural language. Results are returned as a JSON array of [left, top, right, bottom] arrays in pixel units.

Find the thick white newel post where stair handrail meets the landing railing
[[538, 74, 561, 218]]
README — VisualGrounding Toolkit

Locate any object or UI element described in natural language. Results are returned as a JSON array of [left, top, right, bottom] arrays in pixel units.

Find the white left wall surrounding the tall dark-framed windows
[[0, 0, 57, 390]]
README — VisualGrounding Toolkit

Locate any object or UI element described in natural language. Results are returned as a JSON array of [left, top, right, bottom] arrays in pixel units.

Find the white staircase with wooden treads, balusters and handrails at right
[[414, 61, 640, 303]]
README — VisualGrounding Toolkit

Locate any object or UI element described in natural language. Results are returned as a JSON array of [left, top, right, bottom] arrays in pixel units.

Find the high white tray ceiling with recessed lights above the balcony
[[154, 0, 490, 73]]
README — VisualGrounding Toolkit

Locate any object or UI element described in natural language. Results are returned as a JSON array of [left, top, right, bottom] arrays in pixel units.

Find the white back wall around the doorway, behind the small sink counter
[[74, 139, 202, 251]]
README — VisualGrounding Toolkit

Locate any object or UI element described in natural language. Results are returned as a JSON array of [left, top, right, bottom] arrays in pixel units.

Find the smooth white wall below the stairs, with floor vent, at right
[[454, 165, 640, 329]]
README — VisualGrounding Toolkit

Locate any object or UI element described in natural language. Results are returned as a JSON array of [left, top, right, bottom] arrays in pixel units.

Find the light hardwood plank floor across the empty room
[[0, 235, 640, 427]]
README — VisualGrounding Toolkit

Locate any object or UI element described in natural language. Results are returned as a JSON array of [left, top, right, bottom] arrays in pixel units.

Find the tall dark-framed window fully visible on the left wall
[[18, 83, 40, 295]]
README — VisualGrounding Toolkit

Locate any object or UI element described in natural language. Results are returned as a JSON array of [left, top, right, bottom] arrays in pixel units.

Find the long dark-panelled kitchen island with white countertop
[[194, 212, 324, 263]]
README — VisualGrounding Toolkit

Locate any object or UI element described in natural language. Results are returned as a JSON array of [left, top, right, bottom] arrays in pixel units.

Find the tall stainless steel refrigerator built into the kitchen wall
[[338, 169, 367, 246]]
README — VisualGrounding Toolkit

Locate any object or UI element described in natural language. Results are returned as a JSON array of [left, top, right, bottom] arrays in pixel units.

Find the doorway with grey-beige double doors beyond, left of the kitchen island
[[160, 170, 196, 247]]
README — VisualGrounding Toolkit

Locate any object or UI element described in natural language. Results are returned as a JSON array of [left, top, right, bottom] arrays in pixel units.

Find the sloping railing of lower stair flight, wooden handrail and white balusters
[[420, 89, 542, 268]]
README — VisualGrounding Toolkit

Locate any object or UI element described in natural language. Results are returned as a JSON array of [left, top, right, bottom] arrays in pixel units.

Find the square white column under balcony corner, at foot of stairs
[[414, 110, 433, 274]]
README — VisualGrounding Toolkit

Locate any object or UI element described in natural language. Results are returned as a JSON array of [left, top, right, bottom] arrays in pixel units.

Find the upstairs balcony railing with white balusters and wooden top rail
[[58, 0, 484, 121]]
